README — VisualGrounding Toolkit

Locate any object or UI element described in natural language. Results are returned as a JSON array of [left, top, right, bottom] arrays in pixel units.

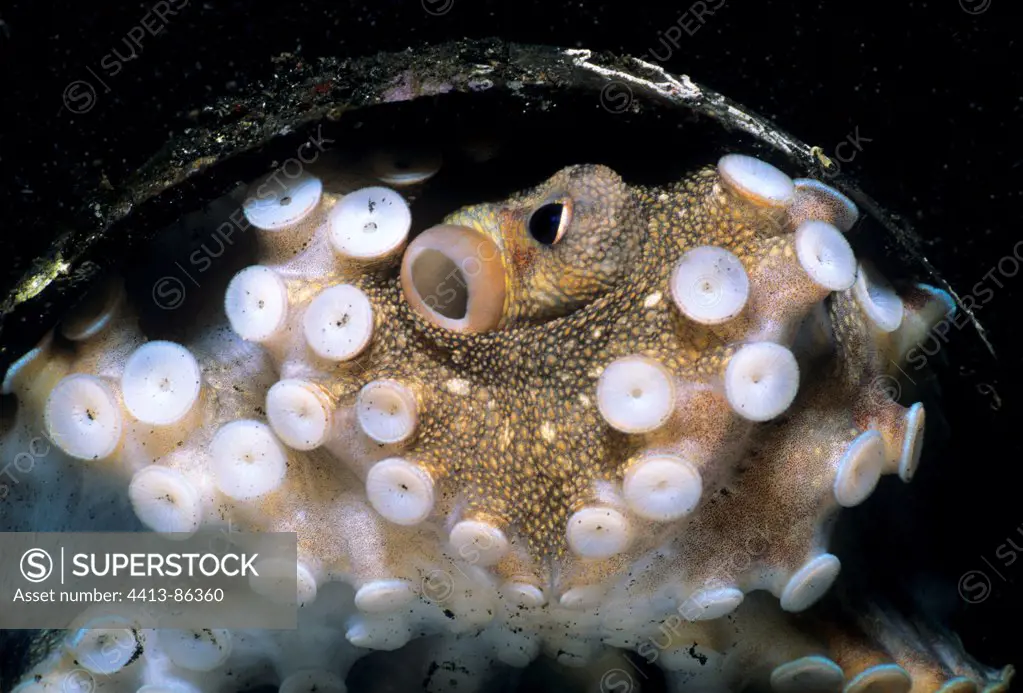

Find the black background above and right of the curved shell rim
[[0, 0, 1023, 668]]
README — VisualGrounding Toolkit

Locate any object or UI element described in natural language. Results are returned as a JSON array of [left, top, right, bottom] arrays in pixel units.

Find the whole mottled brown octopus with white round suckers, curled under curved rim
[[2, 155, 1011, 693]]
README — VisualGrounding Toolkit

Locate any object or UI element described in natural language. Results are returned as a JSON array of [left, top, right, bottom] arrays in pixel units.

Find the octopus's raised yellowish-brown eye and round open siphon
[[402, 165, 642, 332]]
